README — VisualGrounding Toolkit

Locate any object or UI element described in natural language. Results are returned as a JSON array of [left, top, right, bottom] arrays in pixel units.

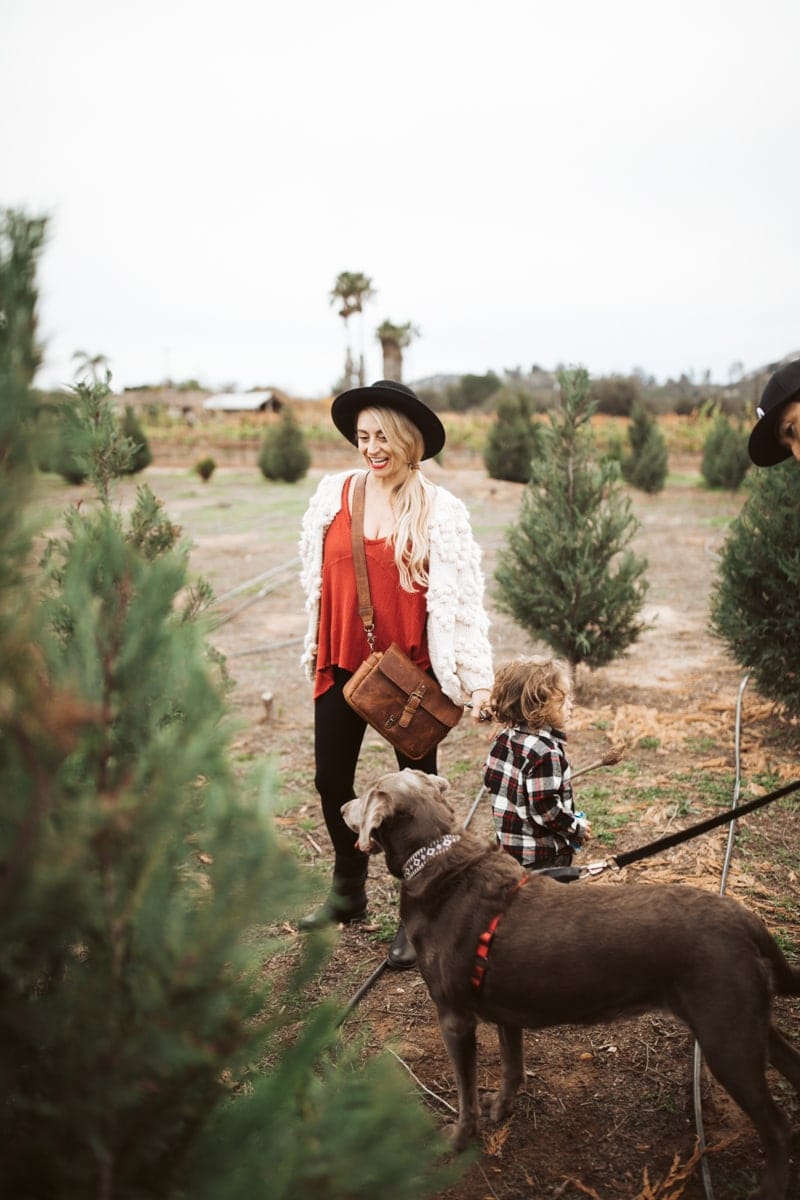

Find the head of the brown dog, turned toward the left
[[342, 767, 455, 878]]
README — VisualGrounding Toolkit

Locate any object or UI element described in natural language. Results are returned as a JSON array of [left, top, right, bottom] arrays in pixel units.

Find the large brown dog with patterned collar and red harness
[[342, 769, 800, 1200]]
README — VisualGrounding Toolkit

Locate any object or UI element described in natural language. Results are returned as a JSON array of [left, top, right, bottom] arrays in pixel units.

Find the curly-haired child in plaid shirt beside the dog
[[483, 658, 590, 869]]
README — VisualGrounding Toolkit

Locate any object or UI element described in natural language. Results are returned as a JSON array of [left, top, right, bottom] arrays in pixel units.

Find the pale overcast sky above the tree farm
[[0, 0, 800, 396]]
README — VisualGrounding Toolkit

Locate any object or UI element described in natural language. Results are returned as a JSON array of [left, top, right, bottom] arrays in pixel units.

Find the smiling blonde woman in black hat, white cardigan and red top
[[300, 379, 493, 967]]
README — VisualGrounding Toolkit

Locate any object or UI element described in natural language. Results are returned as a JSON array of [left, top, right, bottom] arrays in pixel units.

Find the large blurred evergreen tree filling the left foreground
[[0, 216, 455, 1200]]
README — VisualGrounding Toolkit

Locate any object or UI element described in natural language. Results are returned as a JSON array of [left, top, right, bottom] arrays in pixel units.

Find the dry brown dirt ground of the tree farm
[[70, 450, 800, 1200]]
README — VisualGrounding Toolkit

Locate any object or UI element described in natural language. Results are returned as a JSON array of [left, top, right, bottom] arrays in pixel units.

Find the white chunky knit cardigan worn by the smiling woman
[[299, 470, 493, 704]]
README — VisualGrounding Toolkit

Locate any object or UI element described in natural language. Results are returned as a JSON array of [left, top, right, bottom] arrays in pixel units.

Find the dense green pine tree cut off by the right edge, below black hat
[[711, 460, 800, 716]]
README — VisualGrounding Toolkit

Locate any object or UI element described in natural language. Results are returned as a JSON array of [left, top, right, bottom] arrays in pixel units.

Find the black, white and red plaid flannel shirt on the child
[[483, 725, 584, 866]]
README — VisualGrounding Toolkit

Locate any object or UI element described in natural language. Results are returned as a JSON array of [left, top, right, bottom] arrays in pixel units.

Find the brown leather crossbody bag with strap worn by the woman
[[344, 474, 463, 760]]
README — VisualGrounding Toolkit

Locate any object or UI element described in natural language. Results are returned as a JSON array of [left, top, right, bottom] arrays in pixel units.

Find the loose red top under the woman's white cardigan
[[314, 479, 431, 700]]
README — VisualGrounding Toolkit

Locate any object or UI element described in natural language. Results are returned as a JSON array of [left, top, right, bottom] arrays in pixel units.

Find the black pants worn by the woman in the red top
[[314, 667, 437, 862]]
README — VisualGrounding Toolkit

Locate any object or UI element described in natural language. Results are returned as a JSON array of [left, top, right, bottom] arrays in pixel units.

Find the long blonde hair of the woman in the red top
[[359, 408, 432, 592]]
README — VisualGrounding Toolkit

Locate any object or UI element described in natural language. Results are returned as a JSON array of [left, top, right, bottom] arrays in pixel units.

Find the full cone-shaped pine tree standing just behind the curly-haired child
[[495, 370, 646, 667]]
